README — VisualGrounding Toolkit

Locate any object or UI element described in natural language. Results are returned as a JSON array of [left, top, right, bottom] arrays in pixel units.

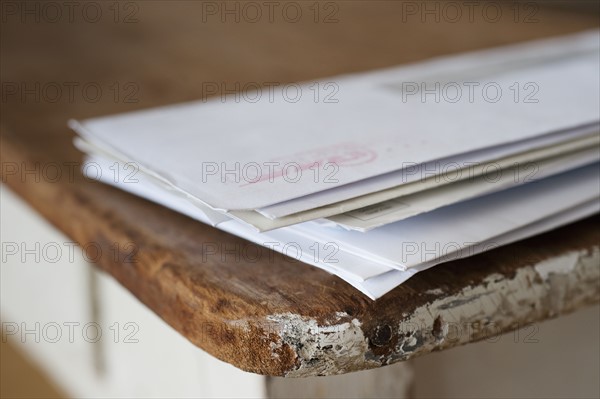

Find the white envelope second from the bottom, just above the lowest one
[[294, 163, 600, 270]]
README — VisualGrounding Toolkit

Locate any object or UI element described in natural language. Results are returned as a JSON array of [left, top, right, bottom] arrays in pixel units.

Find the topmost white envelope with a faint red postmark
[[71, 31, 600, 210]]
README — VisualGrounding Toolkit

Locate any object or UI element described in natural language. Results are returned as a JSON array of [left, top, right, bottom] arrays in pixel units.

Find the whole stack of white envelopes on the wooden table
[[70, 31, 600, 299]]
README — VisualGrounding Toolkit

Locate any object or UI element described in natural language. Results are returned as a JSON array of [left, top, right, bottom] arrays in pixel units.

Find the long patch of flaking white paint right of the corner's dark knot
[[386, 248, 600, 362]]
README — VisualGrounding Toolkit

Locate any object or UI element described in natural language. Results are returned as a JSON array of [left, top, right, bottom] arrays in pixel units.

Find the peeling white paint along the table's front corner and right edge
[[252, 247, 600, 377]]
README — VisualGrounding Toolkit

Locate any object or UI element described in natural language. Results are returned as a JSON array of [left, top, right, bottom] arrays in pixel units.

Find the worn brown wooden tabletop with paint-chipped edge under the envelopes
[[0, 1, 600, 376]]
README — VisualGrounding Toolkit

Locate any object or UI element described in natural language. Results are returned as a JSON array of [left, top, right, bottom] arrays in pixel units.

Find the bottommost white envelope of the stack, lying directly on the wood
[[81, 152, 600, 299]]
